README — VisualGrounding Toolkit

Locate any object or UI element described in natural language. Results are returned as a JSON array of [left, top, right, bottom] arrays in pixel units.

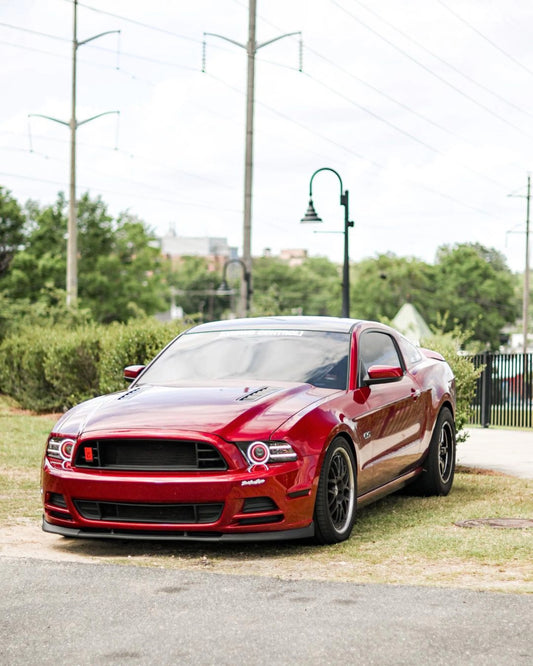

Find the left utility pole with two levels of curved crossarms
[[29, 0, 120, 307]]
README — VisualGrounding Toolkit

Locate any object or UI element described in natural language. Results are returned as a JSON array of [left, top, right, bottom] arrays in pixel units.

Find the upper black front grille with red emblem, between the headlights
[[74, 439, 227, 471]]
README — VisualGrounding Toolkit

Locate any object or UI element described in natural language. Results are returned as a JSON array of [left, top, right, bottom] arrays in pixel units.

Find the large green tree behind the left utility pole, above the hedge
[[0, 189, 167, 322]]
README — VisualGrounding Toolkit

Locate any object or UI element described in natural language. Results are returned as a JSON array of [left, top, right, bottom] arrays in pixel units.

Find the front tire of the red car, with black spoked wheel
[[314, 437, 357, 544]]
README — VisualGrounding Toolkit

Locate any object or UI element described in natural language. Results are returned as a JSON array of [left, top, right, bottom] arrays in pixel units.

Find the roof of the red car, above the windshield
[[188, 316, 362, 333]]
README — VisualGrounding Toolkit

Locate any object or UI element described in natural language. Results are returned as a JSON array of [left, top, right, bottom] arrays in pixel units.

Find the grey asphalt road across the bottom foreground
[[0, 558, 533, 666]]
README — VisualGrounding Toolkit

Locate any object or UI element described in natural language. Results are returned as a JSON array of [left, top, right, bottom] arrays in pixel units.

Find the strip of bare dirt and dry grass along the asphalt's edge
[[0, 519, 533, 593]]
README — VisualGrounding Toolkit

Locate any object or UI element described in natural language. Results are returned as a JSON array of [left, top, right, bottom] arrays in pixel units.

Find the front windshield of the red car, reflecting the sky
[[139, 329, 350, 389]]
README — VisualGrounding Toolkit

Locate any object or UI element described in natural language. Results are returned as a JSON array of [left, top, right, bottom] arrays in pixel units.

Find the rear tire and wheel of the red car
[[414, 407, 456, 495]]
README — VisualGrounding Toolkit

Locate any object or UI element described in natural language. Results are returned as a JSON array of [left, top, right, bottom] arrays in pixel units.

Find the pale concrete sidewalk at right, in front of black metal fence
[[457, 427, 533, 479]]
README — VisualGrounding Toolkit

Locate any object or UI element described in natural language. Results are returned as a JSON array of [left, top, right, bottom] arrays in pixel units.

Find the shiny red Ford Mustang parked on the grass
[[42, 317, 455, 543]]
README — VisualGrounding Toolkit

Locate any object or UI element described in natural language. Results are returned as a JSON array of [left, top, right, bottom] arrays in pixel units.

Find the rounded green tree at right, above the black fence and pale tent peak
[[435, 243, 519, 349]]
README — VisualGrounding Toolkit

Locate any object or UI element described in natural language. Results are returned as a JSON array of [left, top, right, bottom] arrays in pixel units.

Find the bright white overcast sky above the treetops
[[0, 0, 533, 272]]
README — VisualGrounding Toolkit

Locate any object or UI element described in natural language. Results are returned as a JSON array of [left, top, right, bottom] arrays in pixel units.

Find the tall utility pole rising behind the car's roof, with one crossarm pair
[[202, 0, 302, 313]]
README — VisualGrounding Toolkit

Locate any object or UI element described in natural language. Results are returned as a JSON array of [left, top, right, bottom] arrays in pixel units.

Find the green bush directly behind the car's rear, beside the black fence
[[422, 330, 483, 442]]
